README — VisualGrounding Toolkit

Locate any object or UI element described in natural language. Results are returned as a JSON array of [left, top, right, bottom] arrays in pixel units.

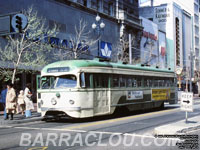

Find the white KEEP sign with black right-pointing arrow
[[181, 92, 193, 112]]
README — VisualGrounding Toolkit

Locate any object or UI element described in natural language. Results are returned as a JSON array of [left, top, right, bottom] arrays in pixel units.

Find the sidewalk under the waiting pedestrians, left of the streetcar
[[0, 104, 42, 126]]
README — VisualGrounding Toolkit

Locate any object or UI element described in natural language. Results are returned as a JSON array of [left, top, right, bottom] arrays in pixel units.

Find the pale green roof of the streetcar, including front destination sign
[[41, 59, 174, 74]]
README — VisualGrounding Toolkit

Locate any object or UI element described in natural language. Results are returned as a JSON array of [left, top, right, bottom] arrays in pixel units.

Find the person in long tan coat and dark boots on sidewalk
[[5, 83, 16, 120]]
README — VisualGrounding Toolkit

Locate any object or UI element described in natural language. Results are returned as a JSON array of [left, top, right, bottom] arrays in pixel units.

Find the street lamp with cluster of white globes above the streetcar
[[92, 14, 105, 57]]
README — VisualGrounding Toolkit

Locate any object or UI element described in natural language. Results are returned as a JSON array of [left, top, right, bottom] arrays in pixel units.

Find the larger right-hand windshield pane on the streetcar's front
[[55, 75, 77, 88]]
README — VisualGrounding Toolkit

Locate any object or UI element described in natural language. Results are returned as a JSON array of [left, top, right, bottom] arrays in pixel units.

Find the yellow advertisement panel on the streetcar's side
[[151, 89, 170, 100]]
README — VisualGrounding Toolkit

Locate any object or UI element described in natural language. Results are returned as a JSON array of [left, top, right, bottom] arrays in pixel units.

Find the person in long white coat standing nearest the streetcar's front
[[24, 83, 34, 117]]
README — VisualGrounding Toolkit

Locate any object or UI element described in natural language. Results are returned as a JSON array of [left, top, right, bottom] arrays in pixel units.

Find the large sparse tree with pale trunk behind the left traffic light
[[0, 6, 58, 83]]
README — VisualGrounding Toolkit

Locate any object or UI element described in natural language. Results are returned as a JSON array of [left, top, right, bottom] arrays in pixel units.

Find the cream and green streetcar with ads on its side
[[37, 59, 177, 118]]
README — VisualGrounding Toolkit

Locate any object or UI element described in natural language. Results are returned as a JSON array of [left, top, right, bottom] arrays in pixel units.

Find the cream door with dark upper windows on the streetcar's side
[[93, 74, 111, 115]]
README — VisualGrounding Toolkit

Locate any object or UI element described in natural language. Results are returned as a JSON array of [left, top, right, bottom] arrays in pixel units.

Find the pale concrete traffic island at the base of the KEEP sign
[[154, 116, 200, 135]]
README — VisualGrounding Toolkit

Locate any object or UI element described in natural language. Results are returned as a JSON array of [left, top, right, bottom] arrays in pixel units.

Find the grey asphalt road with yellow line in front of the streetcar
[[0, 100, 200, 150]]
